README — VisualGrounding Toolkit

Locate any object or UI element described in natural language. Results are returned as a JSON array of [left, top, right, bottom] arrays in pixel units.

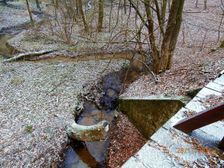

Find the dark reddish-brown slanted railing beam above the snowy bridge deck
[[174, 103, 224, 133]]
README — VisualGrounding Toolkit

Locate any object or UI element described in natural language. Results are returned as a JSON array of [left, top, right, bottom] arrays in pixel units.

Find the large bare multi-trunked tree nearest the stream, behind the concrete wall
[[129, 0, 184, 73]]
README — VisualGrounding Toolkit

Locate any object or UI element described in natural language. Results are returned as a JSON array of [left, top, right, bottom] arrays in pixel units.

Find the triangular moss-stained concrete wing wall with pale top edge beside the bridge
[[119, 96, 186, 138]]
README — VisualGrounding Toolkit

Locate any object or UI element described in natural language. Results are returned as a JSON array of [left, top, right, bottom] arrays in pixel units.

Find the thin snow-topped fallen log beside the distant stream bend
[[3, 50, 56, 63]]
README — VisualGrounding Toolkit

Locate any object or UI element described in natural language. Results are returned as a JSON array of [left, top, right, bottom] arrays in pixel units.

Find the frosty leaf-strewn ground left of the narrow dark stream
[[0, 60, 128, 167]]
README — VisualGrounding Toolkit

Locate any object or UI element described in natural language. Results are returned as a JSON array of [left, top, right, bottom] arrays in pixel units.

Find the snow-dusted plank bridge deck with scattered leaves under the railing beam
[[122, 75, 224, 168]]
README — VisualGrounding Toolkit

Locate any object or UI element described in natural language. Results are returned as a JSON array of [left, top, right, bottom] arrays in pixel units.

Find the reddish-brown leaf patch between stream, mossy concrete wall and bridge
[[107, 113, 146, 168]]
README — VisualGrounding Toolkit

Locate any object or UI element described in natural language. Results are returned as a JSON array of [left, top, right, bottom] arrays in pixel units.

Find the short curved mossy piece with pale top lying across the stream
[[67, 120, 109, 142]]
